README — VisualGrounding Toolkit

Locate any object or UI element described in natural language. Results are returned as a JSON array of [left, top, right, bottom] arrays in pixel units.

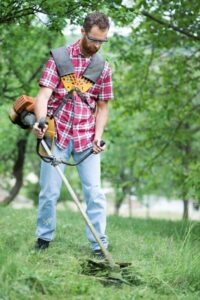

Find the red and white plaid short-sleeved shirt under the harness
[[39, 41, 113, 152]]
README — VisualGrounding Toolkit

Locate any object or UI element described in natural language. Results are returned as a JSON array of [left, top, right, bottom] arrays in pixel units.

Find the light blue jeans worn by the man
[[36, 140, 108, 250]]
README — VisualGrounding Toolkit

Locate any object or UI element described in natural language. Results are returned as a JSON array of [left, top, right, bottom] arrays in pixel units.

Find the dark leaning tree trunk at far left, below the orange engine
[[1, 138, 28, 205]]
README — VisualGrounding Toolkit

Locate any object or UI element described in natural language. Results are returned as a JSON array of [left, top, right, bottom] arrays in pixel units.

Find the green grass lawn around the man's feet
[[0, 207, 200, 300]]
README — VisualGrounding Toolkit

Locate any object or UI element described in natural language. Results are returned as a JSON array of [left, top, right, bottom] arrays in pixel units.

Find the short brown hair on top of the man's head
[[83, 11, 110, 32]]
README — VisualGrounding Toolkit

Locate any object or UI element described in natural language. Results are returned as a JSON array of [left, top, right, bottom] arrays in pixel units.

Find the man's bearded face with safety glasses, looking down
[[81, 25, 108, 56]]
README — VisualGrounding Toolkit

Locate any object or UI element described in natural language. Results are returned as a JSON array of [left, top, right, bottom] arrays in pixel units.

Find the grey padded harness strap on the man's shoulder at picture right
[[83, 53, 105, 83]]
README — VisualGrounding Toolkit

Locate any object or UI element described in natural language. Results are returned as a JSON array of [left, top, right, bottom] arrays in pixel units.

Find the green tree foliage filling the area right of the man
[[101, 1, 200, 210]]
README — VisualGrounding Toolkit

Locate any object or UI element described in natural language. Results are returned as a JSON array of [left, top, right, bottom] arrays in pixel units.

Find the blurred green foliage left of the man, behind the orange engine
[[0, 14, 64, 199]]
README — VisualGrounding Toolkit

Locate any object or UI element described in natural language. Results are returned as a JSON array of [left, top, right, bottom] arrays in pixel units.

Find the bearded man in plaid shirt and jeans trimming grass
[[34, 12, 113, 256]]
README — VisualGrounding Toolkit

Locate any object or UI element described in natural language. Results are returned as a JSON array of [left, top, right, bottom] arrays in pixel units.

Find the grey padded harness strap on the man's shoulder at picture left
[[50, 46, 74, 77]]
